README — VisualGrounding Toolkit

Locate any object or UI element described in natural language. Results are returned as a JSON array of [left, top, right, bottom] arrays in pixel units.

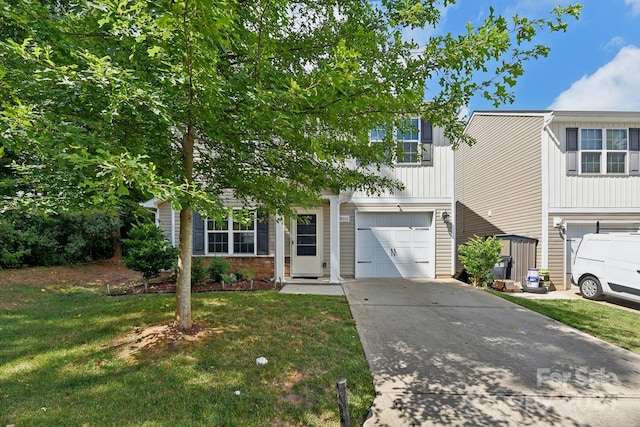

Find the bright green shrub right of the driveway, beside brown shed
[[458, 236, 502, 287]]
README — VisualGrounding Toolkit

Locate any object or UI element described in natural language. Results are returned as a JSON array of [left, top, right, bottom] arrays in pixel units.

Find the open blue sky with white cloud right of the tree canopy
[[414, 0, 640, 112]]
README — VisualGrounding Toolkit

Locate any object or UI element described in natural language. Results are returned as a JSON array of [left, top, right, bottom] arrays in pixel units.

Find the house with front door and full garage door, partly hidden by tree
[[145, 118, 455, 283]]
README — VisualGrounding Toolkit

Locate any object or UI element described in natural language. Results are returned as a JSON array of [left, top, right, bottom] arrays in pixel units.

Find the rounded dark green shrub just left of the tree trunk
[[122, 224, 178, 279]]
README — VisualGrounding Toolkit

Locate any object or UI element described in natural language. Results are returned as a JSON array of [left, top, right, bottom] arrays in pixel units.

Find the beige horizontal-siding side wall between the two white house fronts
[[455, 114, 543, 256]]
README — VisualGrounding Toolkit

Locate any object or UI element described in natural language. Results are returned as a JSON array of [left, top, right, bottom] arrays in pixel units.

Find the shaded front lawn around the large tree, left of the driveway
[[0, 284, 374, 427]]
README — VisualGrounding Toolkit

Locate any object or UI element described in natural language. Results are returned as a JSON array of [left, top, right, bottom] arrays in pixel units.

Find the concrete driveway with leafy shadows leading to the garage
[[343, 279, 640, 427]]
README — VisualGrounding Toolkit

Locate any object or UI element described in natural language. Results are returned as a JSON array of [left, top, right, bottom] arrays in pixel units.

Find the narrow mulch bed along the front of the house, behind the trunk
[[108, 279, 282, 296]]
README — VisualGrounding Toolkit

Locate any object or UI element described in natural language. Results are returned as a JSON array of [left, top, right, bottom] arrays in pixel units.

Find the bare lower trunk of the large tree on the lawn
[[176, 208, 193, 331]]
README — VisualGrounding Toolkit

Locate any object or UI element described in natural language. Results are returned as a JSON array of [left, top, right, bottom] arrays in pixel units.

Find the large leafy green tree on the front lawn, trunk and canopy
[[0, 0, 580, 329]]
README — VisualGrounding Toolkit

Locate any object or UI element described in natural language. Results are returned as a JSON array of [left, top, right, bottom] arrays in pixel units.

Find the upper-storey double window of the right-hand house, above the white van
[[580, 129, 629, 174]]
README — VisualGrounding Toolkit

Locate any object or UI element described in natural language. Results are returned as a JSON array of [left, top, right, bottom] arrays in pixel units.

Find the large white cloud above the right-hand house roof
[[549, 45, 640, 111]]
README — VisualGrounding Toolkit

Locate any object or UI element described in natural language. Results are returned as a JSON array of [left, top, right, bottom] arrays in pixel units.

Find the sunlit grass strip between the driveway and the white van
[[489, 291, 640, 354]]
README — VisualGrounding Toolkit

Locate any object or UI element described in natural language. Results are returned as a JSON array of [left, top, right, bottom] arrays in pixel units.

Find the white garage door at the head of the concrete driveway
[[356, 213, 435, 278]]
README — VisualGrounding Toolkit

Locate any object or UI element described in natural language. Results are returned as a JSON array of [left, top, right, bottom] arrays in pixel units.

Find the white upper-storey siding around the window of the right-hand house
[[546, 121, 640, 209]]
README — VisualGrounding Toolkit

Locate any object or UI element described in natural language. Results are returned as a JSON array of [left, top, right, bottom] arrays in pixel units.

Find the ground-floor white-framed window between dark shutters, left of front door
[[207, 214, 256, 255]]
